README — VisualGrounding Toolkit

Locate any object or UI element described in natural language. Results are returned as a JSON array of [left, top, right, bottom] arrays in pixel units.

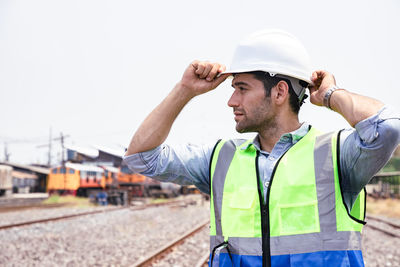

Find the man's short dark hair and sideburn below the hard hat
[[249, 71, 305, 114]]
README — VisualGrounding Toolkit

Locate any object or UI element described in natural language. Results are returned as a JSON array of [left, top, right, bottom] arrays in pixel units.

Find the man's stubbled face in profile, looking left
[[228, 73, 275, 133]]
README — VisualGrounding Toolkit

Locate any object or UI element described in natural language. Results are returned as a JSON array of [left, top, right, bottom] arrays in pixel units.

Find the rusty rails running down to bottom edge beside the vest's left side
[[133, 220, 210, 267]]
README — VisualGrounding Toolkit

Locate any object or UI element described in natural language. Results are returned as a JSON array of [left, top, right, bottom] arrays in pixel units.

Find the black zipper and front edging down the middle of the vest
[[256, 150, 288, 267]]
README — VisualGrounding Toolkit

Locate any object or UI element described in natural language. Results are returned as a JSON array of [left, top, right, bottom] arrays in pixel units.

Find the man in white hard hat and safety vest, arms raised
[[124, 30, 400, 266]]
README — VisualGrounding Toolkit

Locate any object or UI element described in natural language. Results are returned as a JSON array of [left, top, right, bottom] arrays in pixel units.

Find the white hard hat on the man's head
[[224, 29, 311, 84]]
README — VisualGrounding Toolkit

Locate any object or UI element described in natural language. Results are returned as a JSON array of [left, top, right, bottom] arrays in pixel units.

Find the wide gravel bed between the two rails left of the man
[[0, 196, 209, 266]]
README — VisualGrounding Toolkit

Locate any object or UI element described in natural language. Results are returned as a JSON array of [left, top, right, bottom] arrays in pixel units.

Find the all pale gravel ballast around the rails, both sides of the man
[[0, 196, 400, 267]]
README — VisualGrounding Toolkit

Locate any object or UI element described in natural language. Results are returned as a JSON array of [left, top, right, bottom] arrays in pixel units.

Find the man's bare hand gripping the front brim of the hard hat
[[179, 60, 230, 97]]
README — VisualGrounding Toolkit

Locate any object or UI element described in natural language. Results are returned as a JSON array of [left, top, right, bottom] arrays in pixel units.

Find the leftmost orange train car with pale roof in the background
[[47, 163, 106, 196]]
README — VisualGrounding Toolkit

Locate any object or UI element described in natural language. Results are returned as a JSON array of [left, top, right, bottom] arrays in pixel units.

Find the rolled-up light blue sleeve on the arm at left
[[124, 144, 213, 194]]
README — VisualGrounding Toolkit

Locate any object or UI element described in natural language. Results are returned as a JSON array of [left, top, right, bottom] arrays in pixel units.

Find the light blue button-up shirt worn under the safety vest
[[124, 107, 400, 207]]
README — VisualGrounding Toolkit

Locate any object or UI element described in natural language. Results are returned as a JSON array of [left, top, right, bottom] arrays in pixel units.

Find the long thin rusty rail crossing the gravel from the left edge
[[0, 200, 195, 230]]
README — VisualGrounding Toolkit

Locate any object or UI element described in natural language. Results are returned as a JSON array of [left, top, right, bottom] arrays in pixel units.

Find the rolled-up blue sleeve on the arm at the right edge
[[340, 107, 400, 206]]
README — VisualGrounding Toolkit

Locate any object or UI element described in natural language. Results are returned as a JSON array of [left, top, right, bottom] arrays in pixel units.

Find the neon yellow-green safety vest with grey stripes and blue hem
[[210, 128, 365, 267]]
